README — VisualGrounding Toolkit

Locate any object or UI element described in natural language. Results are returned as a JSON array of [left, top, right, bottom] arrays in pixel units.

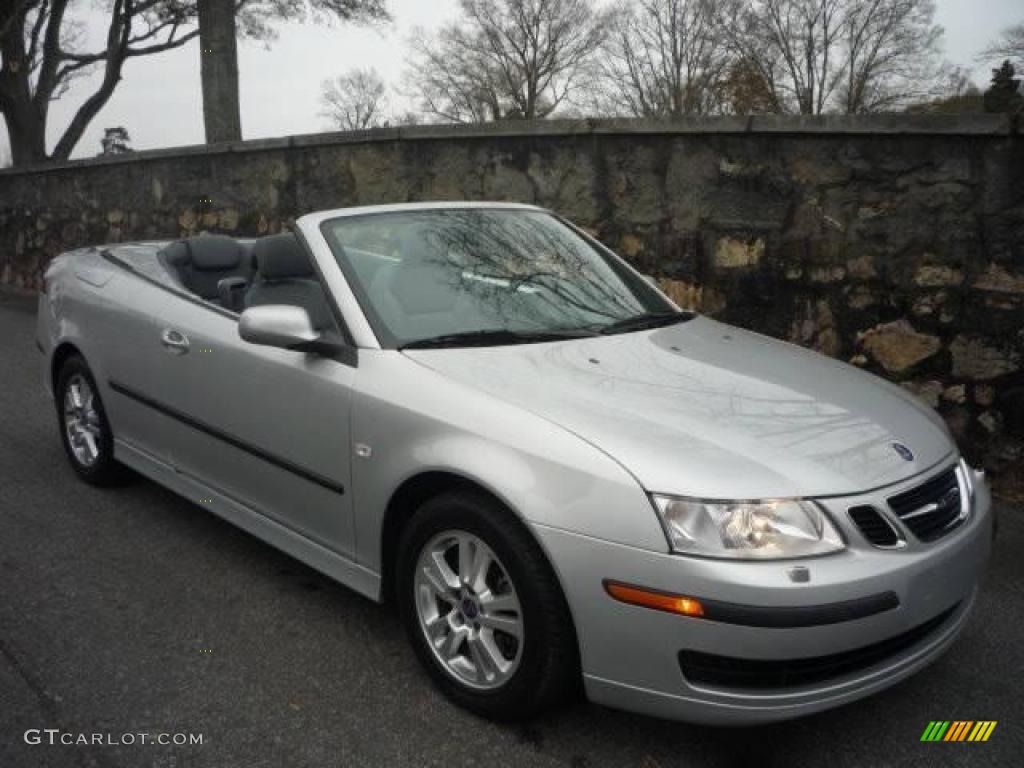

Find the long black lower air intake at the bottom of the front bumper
[[679, 603, 959, 688]]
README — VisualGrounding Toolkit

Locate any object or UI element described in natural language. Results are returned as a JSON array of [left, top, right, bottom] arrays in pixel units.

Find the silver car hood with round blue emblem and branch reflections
[[407, 316, 955, 499]]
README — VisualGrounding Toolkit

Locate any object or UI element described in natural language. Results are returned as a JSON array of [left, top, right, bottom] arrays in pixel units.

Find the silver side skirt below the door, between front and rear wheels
[[114, 438, 381, 602]]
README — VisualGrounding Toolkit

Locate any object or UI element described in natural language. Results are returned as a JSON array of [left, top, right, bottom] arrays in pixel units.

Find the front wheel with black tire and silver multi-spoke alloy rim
[[395, 490, 579, 720]]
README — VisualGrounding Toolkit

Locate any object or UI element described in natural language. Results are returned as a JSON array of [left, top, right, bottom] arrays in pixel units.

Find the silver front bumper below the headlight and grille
[[535, 466, 992, 725]]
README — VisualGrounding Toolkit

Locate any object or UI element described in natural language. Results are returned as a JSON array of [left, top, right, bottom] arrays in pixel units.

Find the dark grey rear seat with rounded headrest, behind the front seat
[[160, 234, 252, 309]]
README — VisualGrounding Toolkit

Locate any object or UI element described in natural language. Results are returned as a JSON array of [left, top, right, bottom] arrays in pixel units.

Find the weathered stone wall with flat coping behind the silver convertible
[[0, 116, 1024, 471]]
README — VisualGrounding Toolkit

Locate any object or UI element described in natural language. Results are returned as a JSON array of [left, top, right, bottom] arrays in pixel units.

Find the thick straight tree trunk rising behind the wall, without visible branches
[[198, 0, 242, 143]]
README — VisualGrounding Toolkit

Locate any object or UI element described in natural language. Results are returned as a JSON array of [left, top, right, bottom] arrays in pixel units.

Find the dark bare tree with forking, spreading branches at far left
[[0, 0, 198, 166]]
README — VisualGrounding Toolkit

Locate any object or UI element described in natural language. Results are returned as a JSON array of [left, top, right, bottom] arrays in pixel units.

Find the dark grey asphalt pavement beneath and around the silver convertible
[[0, 293, 1024, 768]]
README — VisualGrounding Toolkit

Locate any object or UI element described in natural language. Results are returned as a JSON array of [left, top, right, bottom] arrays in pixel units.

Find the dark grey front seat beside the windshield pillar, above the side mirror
[[245, 232, 336, 331]]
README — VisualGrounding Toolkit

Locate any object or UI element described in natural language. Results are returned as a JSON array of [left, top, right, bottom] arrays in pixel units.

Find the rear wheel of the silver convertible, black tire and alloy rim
[[54, 354, 129, 485]]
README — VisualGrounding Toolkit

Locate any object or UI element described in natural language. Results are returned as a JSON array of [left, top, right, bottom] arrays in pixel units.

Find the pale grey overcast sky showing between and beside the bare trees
[[0, 0, 1024, 158]]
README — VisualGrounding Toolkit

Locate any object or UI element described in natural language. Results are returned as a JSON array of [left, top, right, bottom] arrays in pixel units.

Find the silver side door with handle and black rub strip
[[137, 297, 354, 555]]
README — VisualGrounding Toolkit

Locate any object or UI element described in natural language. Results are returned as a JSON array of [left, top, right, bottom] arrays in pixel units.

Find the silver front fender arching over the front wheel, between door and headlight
[[351, 350, 668, 571]]
